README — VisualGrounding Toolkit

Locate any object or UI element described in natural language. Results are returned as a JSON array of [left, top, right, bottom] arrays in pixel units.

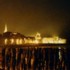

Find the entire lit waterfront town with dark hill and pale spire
[[0, 25, 66, 45]]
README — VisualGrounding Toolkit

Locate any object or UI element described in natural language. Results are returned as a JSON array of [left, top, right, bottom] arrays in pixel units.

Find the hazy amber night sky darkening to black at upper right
[[0, 0, 70, 36]]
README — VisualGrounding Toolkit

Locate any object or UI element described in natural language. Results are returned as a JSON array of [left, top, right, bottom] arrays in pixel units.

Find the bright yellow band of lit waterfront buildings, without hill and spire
[[5, 33, 66, 45]]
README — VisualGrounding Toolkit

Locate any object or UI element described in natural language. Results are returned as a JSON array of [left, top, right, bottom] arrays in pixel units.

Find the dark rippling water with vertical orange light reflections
[[0, 47, 70, 70]]
